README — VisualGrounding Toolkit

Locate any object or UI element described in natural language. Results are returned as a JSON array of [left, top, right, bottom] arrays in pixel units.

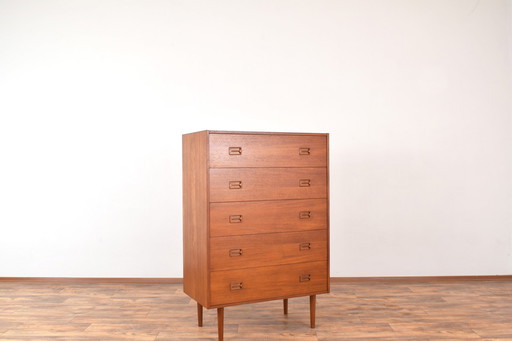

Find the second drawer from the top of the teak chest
[[210, 168, 327, 202]]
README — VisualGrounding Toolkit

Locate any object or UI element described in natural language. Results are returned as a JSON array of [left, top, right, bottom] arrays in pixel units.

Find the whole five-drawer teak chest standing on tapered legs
[[183, 131, 329, 340]]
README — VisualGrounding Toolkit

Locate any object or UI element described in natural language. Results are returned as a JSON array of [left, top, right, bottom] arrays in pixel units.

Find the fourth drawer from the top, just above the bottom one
[[210, 230, 327, 271]]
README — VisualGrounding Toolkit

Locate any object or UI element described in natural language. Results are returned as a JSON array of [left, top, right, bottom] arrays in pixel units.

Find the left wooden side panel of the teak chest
[[183, 132, 209, 306]]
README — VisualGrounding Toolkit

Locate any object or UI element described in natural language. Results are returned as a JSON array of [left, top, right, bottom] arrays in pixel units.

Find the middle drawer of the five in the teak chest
[[210, 199, 327, 237]]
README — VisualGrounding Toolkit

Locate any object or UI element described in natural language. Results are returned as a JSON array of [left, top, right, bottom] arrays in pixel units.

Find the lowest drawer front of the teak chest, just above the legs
[[210, 261, 328, 306]]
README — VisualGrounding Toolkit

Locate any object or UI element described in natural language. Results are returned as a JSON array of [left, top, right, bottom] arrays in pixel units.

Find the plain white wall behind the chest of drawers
[[0, 0, 512, 277]]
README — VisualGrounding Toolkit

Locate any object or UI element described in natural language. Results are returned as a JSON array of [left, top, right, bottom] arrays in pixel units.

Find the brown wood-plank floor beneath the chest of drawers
[[0, 281, 512, 341]]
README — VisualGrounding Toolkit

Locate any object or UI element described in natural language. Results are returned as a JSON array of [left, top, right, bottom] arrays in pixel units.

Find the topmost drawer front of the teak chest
[[210, 134, 327, 168]]
